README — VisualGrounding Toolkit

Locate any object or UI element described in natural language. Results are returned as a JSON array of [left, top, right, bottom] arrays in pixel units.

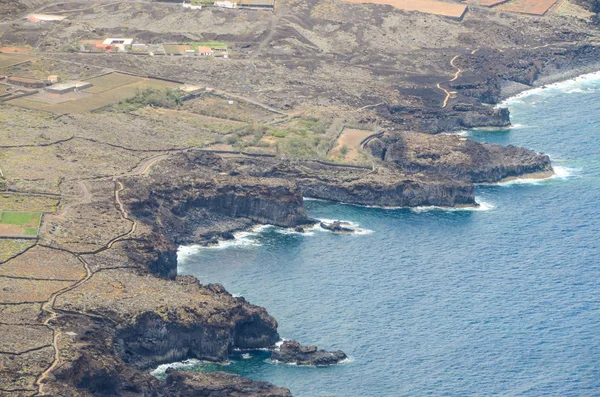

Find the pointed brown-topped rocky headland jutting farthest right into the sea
[[368, 133, 552, 183]]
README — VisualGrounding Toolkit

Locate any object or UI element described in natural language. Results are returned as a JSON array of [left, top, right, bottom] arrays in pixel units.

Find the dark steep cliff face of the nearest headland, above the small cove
[[117, 284, 279, 369]]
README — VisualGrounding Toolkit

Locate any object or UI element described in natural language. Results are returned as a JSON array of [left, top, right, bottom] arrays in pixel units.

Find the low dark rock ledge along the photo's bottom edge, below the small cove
[[165, 369, 292, 397]]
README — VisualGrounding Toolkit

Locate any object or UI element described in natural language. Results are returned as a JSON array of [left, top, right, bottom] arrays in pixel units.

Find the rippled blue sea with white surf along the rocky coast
[[157, 75, 600, 397]]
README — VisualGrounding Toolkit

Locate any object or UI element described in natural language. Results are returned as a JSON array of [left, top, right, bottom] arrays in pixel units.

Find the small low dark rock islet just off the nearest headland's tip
[[271, 340, 348, 365]]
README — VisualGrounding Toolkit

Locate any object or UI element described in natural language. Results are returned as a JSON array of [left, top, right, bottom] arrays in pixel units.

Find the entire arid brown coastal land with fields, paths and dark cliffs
[[0, 0, 600, 396]]
